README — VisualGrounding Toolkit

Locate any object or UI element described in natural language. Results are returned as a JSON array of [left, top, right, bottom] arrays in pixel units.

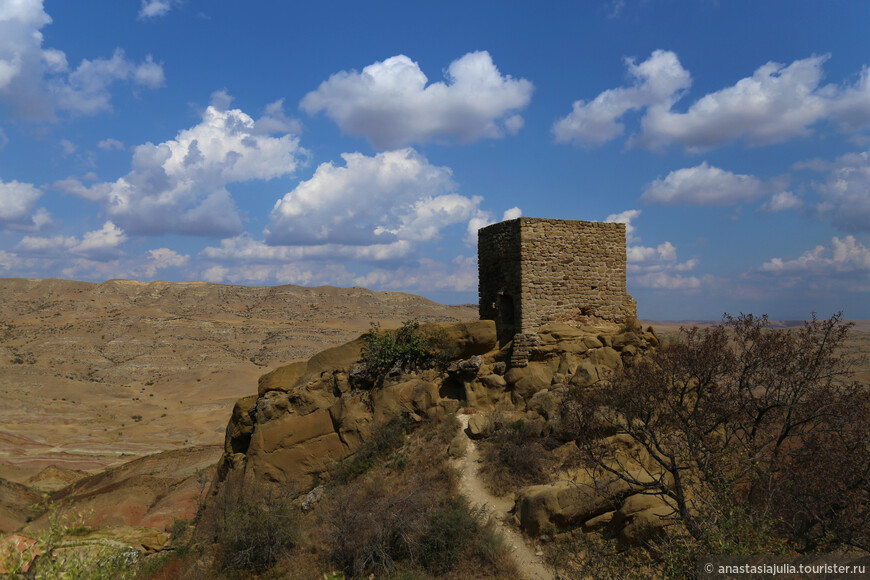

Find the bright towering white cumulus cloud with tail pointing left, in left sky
[[55, 101, 307, 236]]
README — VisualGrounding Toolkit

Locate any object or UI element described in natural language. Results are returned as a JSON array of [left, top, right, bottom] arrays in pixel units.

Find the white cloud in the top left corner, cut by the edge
[[0, 0, 165, 119]]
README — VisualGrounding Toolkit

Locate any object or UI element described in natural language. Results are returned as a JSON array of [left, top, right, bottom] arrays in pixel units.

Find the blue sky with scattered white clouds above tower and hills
[[0, 0, 870, 319]]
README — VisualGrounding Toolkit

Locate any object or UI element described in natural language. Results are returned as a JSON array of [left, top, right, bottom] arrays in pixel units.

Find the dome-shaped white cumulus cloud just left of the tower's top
[[264, 148, 481, 246]]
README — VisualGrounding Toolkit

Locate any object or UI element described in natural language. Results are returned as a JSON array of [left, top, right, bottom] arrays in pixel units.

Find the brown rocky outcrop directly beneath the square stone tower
[[216, 321, 657, 498]]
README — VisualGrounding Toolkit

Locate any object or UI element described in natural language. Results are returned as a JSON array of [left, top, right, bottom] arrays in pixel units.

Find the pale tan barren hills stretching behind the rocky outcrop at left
[[0, 278, 477, 483]]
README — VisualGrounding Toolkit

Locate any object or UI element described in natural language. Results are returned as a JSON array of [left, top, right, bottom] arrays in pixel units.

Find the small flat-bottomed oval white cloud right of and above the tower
[[641, 161, 769, 205]]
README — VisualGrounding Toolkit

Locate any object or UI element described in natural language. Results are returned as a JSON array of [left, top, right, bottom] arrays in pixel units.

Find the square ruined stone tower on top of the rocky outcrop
[[478, 217, 637, 342]]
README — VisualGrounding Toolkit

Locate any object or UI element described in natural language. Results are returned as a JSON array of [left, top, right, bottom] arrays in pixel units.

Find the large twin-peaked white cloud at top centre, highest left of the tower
[[300, 51, 533, 149]]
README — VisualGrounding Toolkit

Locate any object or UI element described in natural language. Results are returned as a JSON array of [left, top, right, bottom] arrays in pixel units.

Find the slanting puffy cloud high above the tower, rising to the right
[[552, 50, 692, 145]]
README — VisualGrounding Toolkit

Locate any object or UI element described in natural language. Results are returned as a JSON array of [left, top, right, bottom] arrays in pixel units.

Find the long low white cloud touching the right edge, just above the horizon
[[758, 236, 870, 275]]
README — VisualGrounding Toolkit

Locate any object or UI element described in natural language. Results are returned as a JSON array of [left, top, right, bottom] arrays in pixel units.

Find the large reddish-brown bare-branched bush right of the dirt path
[[563, 314, 870, 554]]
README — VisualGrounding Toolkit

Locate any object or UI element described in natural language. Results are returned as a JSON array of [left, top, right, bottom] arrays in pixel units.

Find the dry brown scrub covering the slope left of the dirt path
[[322, 417, 514, 578]]
